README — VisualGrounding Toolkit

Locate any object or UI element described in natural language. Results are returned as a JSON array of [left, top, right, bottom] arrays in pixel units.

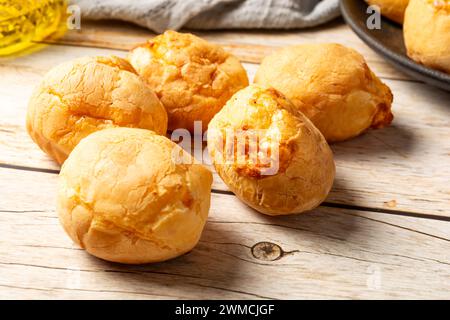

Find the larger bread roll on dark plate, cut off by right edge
[[403, 0, 450, 73]]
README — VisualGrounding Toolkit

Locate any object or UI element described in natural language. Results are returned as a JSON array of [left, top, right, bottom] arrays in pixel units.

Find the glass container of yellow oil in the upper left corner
[[0, 0, 66, 56]]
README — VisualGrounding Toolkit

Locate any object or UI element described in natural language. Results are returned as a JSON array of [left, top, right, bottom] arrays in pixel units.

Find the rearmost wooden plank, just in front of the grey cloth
[[48, 20, 411, 80]]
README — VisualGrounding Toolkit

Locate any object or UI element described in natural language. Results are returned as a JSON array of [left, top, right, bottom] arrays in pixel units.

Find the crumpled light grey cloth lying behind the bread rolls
[[71, 0, 339, 32]]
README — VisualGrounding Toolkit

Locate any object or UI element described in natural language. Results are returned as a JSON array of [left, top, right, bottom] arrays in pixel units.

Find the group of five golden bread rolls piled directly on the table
[[27, 31, 393, 264]]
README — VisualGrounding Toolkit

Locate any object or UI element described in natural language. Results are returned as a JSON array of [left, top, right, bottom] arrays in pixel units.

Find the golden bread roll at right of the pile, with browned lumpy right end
[[255, 44, 393, 142]]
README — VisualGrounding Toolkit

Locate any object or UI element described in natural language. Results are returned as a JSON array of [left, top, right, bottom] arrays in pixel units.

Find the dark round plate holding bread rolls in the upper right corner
[[340, 0, 450, 91]]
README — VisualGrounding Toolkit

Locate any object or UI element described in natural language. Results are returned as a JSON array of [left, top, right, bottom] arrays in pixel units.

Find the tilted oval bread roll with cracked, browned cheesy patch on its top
[[208, 85, 335, 215]]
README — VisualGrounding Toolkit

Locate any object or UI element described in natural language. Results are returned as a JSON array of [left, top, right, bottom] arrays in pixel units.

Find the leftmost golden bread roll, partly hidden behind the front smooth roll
[[27, 56, 167, 164]]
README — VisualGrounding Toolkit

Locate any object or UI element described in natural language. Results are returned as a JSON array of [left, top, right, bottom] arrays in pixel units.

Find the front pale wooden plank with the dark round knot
[[0, 169, 450, 299]]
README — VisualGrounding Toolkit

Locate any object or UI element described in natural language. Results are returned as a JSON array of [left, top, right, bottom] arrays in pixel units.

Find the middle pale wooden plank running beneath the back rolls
[[0, 45, 450, 218]]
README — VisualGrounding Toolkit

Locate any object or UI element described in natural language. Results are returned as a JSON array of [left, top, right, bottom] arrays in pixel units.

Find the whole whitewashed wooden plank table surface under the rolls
[[0, 21, 450, 299]]
